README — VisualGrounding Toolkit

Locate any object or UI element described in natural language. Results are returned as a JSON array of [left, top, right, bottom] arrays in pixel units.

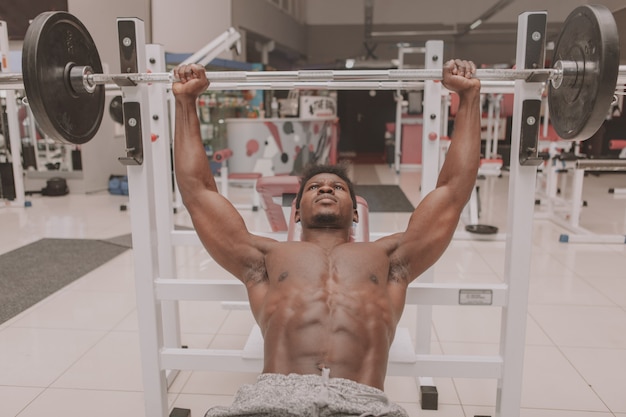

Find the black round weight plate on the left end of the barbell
[[22, 12, 105, 145]]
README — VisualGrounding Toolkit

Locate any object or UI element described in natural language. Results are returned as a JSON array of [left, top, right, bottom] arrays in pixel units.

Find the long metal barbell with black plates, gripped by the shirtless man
[[0, 5, 622, 144]]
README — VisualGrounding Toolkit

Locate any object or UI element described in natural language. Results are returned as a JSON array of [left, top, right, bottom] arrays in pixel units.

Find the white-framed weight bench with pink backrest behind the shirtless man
[[154, 176, 507, 409]]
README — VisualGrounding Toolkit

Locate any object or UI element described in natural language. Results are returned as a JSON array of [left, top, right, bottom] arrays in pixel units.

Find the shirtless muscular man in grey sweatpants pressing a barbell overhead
[[173, 60, 480, 417]]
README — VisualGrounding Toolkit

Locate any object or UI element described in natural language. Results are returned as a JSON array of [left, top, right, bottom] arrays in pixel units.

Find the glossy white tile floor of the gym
[[0, 165, 626, 417]]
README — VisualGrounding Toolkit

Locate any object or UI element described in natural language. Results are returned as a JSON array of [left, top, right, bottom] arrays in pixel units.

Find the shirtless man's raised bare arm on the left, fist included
[[172, 65, 268, 282]]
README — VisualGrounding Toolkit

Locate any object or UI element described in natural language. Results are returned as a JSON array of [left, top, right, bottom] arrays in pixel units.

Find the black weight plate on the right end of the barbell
[[548, 5, 619, 140]]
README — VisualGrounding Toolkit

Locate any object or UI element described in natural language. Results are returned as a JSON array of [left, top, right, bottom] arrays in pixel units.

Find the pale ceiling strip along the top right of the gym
[[305, 0, 626, 27]]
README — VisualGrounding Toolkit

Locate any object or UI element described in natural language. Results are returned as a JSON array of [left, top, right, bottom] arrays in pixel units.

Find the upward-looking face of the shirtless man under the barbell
[[295, 173, 358, 228]]
